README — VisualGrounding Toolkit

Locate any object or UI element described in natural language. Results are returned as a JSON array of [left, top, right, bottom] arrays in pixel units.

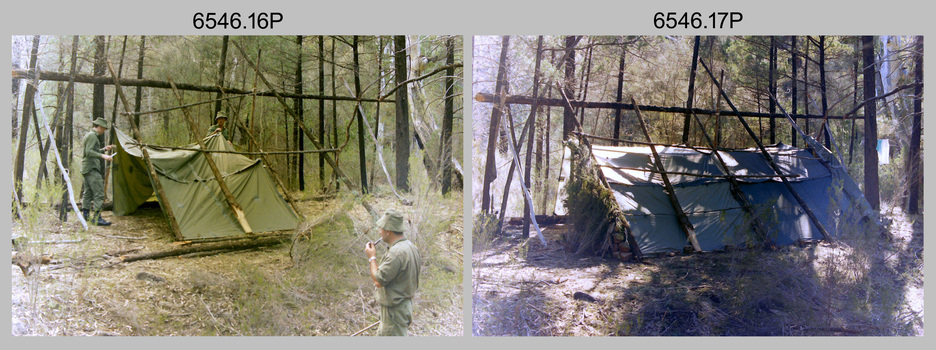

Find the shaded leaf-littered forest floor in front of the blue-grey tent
[[472, 202, 924, 336]]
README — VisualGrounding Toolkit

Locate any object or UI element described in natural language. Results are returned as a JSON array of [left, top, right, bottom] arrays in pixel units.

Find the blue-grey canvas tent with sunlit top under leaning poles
[[555, 138, 872, 254]]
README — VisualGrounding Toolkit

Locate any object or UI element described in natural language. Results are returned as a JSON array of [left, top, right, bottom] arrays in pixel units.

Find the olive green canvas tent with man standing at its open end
[[112, 128, 299, 240]]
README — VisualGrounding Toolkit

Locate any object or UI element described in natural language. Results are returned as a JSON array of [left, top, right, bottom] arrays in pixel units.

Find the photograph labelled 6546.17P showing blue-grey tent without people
[[465, 34, 924, 336]]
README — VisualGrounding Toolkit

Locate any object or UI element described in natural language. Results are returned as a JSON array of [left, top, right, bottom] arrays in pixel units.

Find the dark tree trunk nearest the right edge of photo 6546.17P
[[907, 35, 923, 214]]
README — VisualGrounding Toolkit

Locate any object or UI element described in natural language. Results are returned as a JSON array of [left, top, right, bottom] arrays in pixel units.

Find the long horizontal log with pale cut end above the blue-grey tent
[[475, 92, 864, 120]]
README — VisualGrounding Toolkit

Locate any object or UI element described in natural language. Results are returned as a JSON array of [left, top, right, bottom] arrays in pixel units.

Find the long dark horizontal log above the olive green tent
[[13, 69, 394, 103]]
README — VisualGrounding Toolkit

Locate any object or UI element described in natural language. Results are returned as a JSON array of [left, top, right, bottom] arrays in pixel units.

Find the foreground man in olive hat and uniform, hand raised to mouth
[[364, 210, 420, 336]]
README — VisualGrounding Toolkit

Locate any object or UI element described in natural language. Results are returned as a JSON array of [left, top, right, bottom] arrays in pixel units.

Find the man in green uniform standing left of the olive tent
[[81, 118, 114, 226]]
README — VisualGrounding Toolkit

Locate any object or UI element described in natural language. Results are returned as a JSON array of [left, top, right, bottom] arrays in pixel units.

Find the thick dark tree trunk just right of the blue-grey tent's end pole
[[861, 36, 881, 210]]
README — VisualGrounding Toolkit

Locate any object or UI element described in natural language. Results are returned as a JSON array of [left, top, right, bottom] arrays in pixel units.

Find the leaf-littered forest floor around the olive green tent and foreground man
[[10, 195, 463, 336]]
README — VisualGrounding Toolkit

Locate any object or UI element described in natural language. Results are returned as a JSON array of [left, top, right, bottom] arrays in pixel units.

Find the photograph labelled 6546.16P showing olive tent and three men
[[10, 35, 464, 336]]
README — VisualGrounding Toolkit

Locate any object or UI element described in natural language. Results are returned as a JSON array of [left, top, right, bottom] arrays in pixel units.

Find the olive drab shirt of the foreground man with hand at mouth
[[375, 238, 420, 306]]
